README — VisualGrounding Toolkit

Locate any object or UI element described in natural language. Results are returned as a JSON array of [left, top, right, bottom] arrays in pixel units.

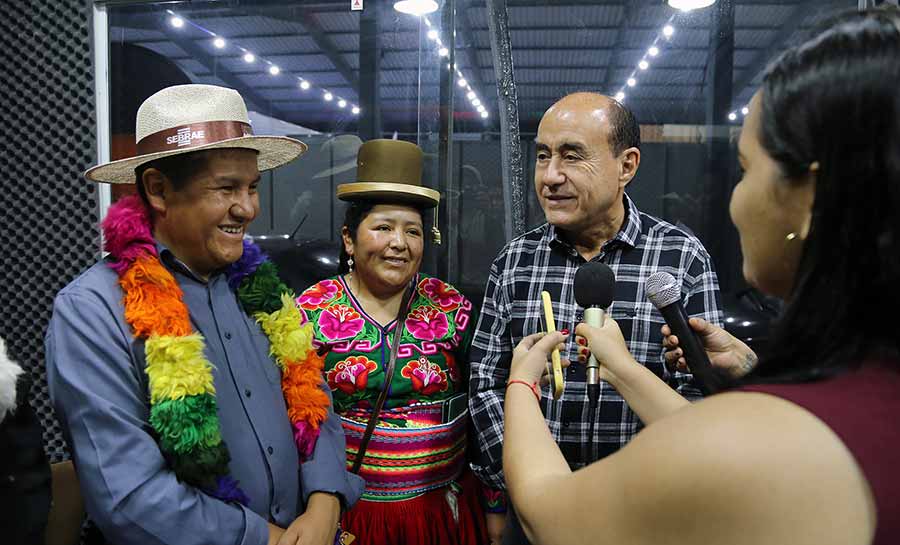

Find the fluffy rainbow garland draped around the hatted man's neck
[[103, 195, 329, 505]]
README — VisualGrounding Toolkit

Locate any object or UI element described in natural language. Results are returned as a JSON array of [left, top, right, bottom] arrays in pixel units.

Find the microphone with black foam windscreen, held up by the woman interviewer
[[575, 261, 616, 409]]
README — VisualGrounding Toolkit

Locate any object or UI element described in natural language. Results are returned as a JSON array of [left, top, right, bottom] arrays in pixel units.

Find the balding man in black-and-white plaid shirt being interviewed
[[469, 93, 722, 543]]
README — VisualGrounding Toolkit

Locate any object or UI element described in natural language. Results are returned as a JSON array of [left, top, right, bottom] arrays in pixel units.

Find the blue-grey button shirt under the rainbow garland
[[45, 245, 364, 545]]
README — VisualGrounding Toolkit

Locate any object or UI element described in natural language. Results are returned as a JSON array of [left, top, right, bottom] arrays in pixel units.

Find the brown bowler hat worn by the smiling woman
[[337, 139, 441, 208]]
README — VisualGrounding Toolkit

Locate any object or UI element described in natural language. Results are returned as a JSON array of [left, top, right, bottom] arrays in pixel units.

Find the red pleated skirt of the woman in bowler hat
[[341, 468, 489, 545]]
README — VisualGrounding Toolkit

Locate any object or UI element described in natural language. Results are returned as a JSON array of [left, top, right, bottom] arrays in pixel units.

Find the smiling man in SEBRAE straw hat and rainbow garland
[[46, 85, 363, 545]]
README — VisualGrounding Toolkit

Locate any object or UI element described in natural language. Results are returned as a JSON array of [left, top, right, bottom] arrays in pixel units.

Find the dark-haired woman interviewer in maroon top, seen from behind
[[503, 10, 900, 545]]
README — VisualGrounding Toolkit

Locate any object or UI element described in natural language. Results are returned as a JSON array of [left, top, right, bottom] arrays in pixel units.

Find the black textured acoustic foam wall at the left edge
[[0, 0, 99, 462]]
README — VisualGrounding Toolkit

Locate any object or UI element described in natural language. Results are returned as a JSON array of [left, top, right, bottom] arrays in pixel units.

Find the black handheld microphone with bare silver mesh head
[[646, 271, 725, 394]]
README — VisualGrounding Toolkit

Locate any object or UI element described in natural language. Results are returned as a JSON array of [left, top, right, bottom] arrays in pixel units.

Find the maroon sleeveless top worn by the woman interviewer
[[742, 362, 900, 545]]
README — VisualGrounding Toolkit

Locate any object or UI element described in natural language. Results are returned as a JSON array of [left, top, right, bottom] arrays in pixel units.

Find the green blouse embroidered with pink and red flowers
[[297, 274, 475, 418]]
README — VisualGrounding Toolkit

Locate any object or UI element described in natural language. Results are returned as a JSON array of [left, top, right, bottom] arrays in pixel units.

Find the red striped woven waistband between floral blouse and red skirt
[[341, 411, 469, 501]]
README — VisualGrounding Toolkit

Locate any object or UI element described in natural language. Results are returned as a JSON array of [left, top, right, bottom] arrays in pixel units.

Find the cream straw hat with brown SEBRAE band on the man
[[84, 84, 306, 184]]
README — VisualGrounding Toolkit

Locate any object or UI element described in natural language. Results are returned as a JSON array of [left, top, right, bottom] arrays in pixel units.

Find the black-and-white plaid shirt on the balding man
[[469, 195, 722, 490]]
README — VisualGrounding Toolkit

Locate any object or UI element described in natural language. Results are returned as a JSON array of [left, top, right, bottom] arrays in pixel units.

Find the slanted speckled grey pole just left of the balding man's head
[[486, 0, 525, 240]]
